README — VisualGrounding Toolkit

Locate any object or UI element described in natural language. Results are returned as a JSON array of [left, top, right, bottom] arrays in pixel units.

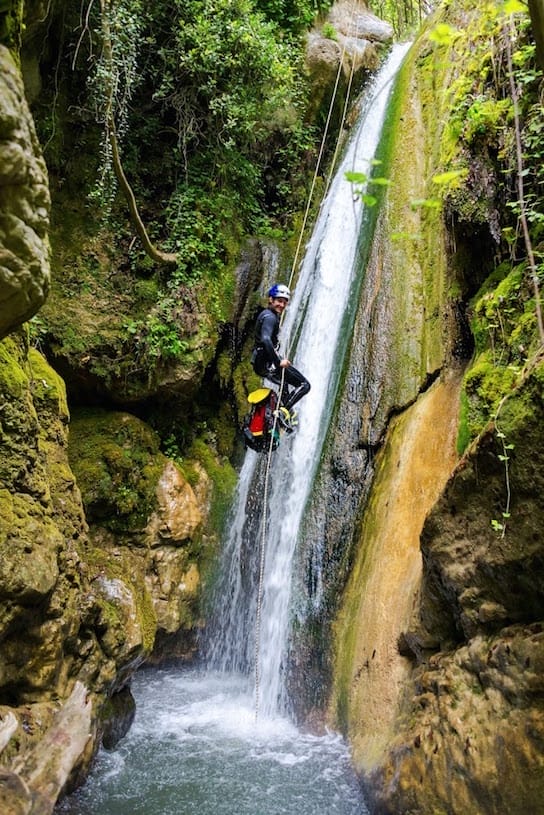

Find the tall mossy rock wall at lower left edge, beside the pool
[[0, 334, 172, 813]]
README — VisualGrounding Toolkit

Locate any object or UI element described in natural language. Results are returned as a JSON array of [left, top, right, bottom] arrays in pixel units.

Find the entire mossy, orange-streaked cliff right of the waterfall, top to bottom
[[332, 2, 544, 815]]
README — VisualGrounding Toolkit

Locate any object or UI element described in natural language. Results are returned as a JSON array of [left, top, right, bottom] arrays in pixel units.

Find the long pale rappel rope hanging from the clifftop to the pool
[[255, 10, 355, 721]]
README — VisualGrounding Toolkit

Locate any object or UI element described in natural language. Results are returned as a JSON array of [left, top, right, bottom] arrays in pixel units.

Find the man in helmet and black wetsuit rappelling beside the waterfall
[[251, 283, 310, 432]]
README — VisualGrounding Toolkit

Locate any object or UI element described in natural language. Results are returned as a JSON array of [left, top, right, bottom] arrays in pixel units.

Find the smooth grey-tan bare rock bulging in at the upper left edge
[[0, 46, 50, 337]]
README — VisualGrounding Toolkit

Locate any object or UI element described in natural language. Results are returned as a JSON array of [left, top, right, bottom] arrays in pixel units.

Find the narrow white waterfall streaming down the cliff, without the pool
[[208, 45, 408, 715]]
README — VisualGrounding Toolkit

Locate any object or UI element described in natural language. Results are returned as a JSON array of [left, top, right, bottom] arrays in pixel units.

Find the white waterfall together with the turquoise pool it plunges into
[[56, 46, 406, 815]]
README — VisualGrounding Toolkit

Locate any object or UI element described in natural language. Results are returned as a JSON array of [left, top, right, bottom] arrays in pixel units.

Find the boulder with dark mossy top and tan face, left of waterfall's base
[[66, 410, 208, 656]]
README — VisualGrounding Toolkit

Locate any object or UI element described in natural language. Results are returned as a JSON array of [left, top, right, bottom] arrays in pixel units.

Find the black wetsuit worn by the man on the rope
[[251, 308, 310, 411]]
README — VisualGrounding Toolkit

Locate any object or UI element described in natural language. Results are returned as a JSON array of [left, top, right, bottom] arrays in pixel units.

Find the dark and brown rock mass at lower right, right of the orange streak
[[367, 363, 544, 815]]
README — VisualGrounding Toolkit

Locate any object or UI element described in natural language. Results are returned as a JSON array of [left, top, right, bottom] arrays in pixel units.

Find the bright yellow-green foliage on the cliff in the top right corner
[[429, 0, 544, 241]]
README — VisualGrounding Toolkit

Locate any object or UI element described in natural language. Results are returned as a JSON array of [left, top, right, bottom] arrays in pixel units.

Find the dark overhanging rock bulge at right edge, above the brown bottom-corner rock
[[421, 366, 544, 642]]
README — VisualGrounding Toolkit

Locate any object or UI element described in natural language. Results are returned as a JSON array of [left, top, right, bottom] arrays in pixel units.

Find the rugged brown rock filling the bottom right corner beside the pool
[[368, 624, 544, 815]]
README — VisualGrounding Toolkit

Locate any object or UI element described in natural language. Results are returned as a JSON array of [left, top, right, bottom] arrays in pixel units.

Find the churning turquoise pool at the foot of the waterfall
[[55, 669, 367, 815]]
